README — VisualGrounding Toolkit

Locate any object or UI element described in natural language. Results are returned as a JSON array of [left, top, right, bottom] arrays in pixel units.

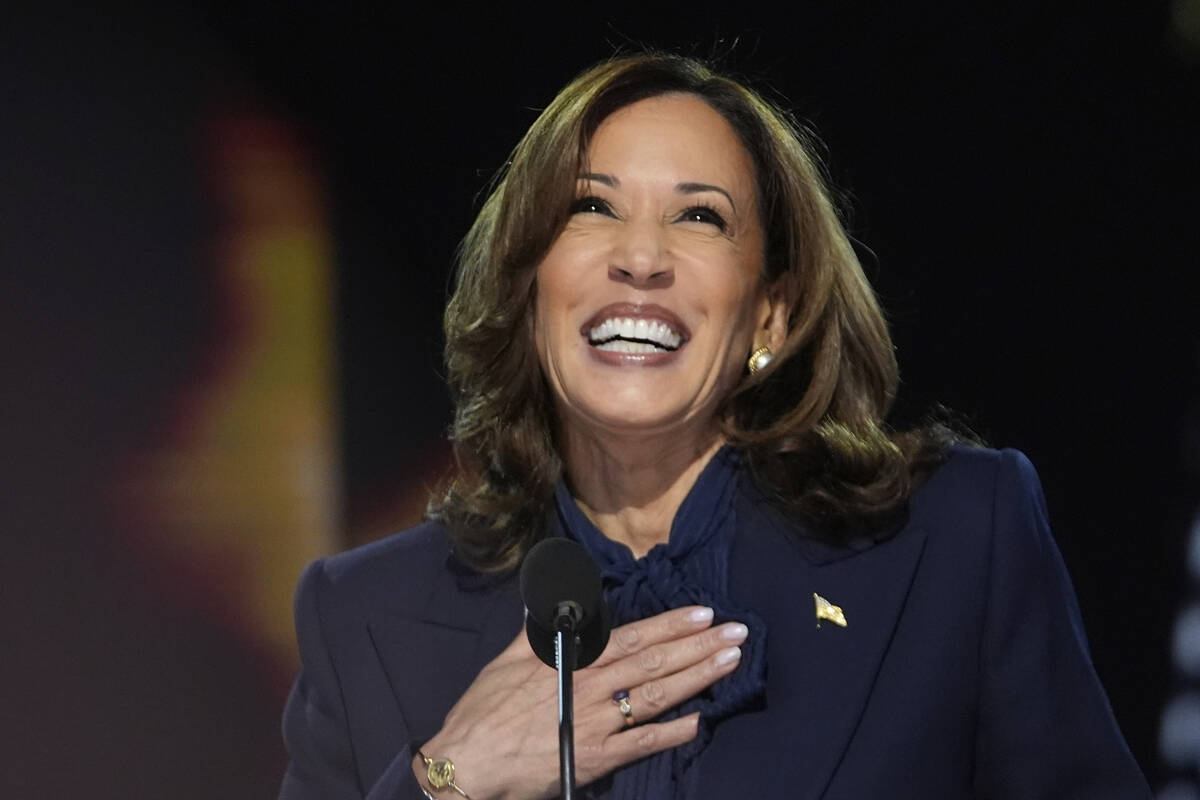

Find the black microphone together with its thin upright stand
[[521, 537, 611, 800]]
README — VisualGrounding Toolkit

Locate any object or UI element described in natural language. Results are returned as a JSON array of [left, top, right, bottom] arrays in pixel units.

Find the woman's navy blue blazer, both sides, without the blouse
[[280, 450, 1150, 800]]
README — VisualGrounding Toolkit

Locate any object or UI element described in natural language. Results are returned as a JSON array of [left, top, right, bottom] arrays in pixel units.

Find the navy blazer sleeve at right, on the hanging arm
[[976, 450, 1151, 800]]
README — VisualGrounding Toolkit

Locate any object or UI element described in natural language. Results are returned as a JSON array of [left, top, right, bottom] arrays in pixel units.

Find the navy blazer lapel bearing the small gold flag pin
[[697, 504, 925, 800]]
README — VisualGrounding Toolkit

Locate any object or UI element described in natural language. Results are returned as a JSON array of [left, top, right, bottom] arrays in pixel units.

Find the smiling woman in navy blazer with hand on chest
[[281, 54, 1148, 800]]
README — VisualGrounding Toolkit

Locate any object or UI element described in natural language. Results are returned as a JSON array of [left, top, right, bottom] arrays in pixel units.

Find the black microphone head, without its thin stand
[[521, 536, 612, 669]]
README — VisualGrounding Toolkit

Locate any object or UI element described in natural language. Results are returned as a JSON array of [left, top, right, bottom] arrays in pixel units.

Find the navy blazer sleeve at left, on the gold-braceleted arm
[[280, 560, 428, 800]]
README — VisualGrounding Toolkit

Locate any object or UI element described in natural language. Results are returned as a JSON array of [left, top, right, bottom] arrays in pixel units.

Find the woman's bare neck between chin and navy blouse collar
[[562, 428, 724, 558]]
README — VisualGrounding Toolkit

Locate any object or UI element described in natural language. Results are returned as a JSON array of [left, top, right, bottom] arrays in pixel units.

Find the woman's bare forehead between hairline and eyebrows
[[588, 94, 755, 194]]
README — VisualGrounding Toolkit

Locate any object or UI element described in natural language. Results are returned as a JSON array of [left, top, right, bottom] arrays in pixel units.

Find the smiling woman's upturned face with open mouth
[[535, 94, 782, 443]]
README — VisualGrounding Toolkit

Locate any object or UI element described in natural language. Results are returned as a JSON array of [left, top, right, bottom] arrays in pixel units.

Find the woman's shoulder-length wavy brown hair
[[430, 53, 949, 571]]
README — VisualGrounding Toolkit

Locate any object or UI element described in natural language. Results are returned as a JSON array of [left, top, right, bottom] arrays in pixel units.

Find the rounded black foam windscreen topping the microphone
[[521, 536, 604, 630]]
